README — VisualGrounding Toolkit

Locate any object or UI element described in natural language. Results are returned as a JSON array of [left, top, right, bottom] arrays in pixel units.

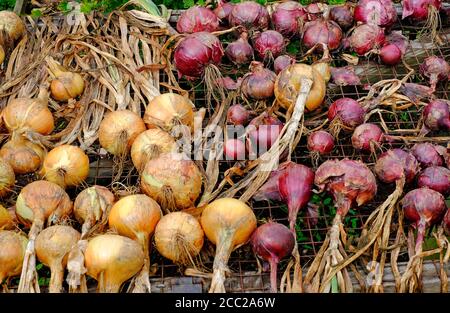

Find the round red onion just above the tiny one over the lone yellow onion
[[253, 30, 285, 60]]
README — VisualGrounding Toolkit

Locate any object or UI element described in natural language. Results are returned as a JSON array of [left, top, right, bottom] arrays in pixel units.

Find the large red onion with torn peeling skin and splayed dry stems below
[[304, 159, 377, 293]]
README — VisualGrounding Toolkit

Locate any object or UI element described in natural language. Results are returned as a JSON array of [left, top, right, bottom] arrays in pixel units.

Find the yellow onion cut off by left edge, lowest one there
[[0, 230, 28, 284]]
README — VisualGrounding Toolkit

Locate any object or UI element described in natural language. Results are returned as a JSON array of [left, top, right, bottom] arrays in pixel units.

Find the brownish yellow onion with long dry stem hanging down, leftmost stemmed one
[[16, 180, 72, 292]]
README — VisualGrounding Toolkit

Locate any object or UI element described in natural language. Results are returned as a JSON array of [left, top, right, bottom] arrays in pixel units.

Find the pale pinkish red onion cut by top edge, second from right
[[355, 0, 397, 27]]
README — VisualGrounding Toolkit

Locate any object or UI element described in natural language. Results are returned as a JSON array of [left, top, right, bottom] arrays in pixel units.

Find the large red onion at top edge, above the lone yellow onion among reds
[[272, 1, 306, 38]]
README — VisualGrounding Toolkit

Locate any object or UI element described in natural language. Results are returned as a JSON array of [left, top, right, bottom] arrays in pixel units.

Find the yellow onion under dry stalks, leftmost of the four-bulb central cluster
[[98, 110, 146, 156]]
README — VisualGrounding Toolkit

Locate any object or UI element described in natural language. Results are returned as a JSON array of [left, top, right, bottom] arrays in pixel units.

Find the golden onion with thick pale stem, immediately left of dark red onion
[[200, 198, 256, 293]]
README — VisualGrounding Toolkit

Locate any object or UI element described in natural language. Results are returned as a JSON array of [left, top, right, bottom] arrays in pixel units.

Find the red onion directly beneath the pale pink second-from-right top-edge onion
[[350, 24, 385, 55]]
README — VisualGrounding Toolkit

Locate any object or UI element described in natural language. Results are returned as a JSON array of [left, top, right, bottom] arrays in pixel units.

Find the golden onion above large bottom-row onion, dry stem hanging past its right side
[[108, 194, 162, 292]]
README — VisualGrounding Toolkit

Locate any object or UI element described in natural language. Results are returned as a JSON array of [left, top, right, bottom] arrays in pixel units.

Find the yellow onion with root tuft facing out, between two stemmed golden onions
[[155, 212, 205, 266]]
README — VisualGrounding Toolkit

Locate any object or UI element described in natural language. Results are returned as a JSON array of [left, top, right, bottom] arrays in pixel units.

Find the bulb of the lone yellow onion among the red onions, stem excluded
[[275, 64, 326, 111]]
